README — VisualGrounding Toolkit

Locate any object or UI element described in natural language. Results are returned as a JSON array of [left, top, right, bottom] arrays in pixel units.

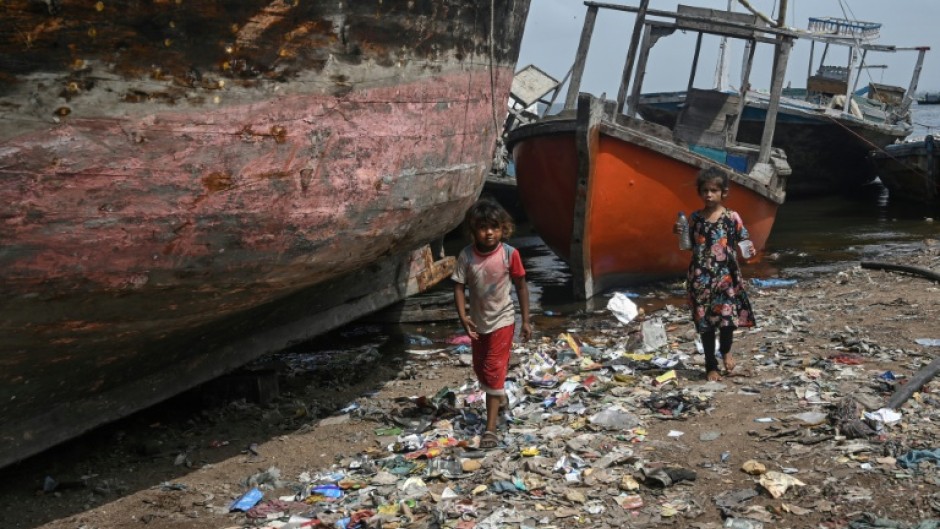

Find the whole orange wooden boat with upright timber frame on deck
[[507, 0, 793, 298]]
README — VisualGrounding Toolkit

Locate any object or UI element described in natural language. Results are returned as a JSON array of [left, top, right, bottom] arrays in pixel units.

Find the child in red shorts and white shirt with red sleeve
[[451, 199, 532, 448]]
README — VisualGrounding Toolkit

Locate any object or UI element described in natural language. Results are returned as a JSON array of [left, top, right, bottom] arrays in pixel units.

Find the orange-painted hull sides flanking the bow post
[[513, 134, 778, 290]]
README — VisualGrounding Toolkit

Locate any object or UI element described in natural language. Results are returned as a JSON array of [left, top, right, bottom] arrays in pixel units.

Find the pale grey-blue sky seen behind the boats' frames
[[517, 0, 940, 99]]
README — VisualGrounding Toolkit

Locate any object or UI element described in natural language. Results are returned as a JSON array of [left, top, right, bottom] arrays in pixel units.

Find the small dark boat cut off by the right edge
[[871, 135, 940, 204]]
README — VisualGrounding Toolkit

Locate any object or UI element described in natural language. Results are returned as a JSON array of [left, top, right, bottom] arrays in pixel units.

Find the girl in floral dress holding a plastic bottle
[[673, 169, 754, 381]]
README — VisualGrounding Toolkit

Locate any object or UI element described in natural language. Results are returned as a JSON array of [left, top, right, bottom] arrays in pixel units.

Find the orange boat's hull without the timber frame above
[[509, 101, 785, 293]]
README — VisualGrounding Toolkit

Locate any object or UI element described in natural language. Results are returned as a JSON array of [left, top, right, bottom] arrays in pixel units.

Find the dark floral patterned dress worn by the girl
[[687, 208, 755, 333]]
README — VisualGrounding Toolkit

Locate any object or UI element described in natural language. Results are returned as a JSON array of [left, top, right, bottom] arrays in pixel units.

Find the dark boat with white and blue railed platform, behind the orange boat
[[639, 18, 929, 197]]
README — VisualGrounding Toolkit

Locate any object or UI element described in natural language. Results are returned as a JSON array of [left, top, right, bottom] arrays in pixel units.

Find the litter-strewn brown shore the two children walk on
[[0, 241, 940, 529]]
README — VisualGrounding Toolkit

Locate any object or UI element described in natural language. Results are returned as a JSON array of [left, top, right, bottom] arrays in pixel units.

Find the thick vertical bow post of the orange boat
[[569, 94, 604, 299]]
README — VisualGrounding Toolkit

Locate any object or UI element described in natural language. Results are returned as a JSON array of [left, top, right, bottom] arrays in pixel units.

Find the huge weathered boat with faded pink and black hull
[[0, 0, 529, 466]]
